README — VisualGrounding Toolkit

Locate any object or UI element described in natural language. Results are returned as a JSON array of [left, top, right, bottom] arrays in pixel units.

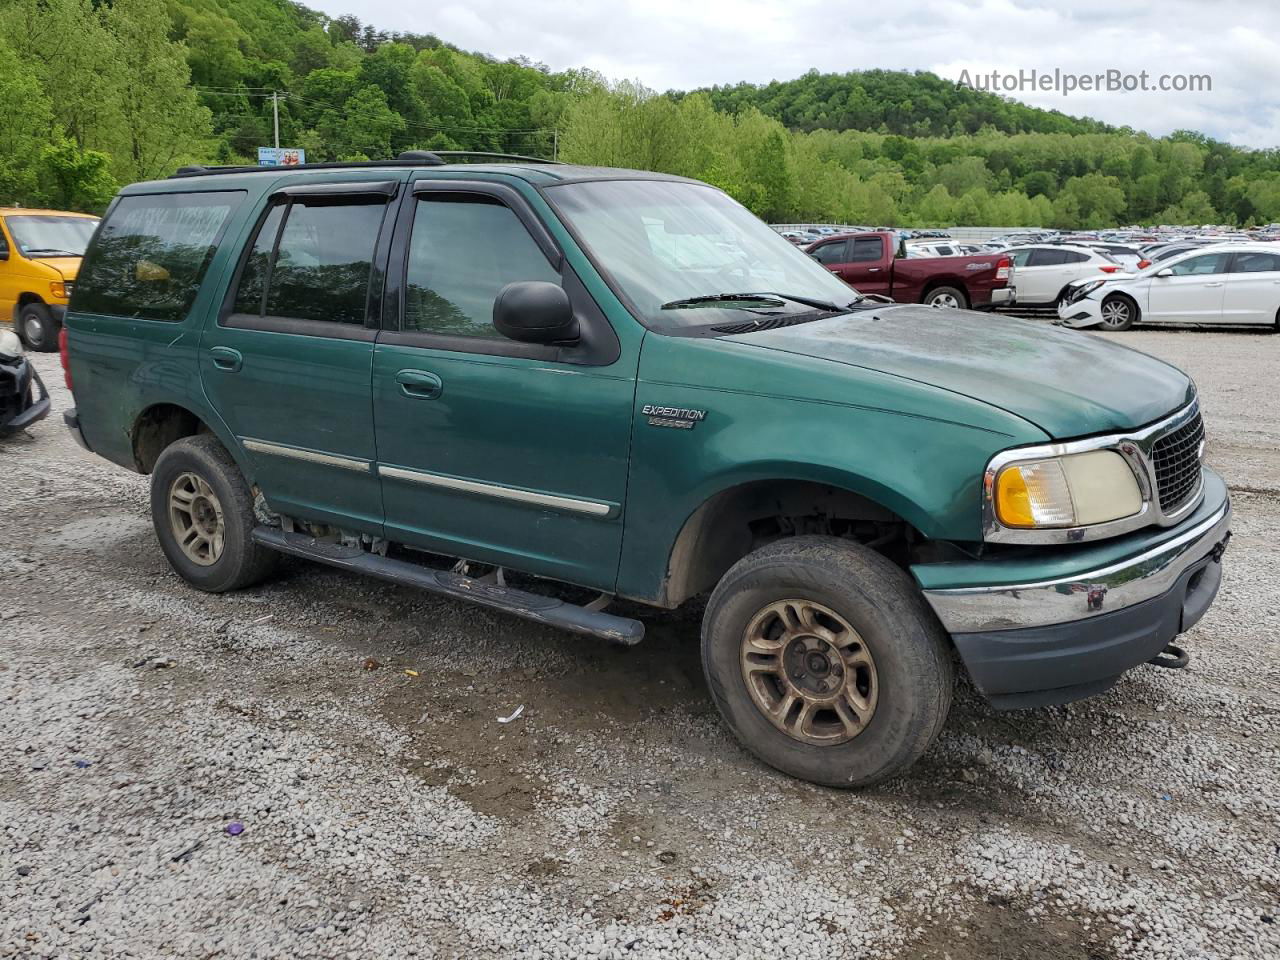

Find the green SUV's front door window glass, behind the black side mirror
[[403, 193, 561, 338]]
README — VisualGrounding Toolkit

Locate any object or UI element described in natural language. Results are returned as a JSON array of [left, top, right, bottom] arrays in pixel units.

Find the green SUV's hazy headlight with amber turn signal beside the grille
[[991, 451, 1143, 530]]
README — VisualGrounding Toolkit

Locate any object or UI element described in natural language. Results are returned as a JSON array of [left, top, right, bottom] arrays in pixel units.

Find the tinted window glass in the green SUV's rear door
[[233, 201, 387, 324]]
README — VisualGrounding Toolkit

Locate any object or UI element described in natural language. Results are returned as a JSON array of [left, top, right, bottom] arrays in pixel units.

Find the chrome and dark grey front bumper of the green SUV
[[916, 470, 1231, 708]]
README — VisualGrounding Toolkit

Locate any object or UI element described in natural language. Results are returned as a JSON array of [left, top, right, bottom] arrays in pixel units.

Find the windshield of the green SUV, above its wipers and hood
[[548, 180, 858, 328]]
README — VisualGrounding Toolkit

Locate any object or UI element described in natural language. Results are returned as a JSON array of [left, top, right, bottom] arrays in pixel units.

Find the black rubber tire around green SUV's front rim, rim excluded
[[703, 536, 954, 787]]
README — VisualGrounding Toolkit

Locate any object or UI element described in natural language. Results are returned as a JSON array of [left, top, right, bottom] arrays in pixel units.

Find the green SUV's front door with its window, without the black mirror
[[374, 179, 636, 590]]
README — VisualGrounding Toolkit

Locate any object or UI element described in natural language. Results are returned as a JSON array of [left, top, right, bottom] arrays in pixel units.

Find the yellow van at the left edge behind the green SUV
[[0, 207, 97, 351]]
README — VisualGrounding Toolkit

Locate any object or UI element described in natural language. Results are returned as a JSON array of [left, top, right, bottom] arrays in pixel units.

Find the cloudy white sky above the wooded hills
[[332, 0, 1280, 147]]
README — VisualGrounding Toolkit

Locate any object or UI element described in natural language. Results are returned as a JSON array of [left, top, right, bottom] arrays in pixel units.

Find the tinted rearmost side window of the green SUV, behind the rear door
[[72, 191, 244, 323]]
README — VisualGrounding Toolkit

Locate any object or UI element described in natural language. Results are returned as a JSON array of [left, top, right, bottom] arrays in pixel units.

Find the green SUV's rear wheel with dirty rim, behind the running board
[[151, 434, 279, 593]]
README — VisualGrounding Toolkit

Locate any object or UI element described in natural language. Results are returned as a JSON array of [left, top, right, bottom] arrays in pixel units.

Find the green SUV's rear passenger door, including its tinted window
[[200, 182, 397, 535]]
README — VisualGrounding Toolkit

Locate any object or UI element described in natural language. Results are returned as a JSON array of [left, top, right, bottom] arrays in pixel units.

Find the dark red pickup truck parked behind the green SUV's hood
[[805, 230, 1014, 310]]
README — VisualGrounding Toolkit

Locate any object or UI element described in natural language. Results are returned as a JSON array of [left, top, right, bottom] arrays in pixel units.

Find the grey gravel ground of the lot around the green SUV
[[0, 332, 1280, 960]]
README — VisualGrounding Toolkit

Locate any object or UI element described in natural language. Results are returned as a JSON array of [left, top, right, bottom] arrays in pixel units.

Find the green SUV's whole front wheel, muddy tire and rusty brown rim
[[703, 536, 954, 787]]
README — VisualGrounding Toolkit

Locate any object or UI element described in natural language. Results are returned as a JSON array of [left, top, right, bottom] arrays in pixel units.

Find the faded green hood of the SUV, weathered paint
[[726, 305, 1196, 439]]
